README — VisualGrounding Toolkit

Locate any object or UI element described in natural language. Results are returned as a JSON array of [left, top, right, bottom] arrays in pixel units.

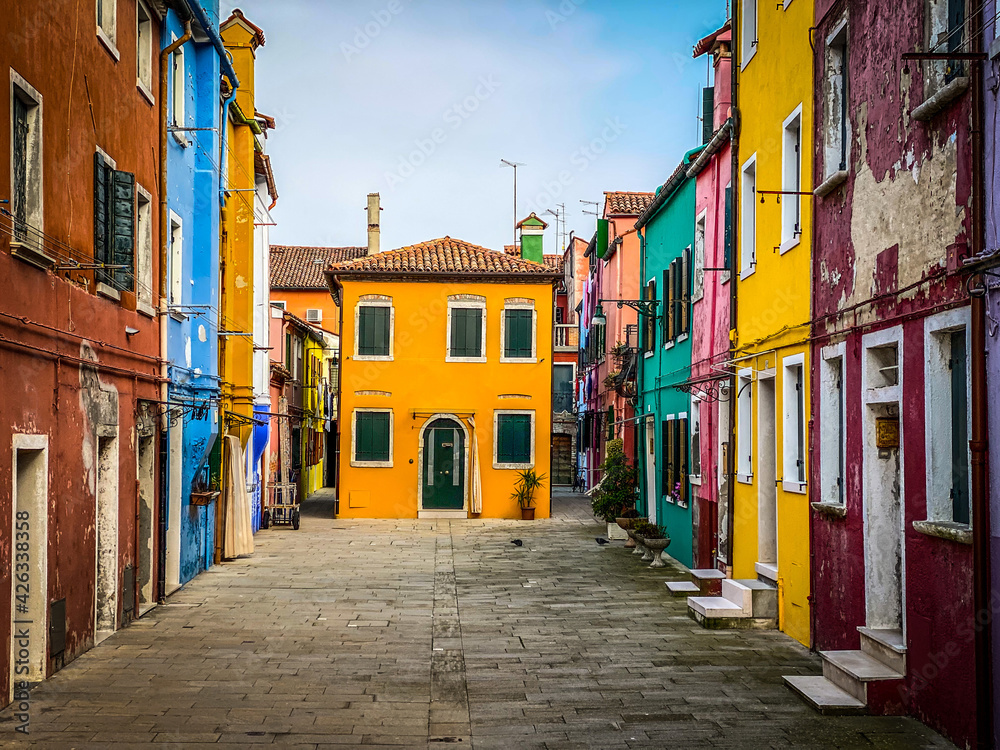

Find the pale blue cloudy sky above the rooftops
[[221, 0, 727, 253]]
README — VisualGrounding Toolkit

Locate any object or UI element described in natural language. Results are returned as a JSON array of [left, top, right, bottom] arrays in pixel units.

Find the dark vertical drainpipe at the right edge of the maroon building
[[969, 4, 993, 748]]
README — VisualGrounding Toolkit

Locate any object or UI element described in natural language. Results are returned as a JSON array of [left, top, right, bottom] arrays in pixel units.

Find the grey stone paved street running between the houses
[[0, 495, 950, 750]]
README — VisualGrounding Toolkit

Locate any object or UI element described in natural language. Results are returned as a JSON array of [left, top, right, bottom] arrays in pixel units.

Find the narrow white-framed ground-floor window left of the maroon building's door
[[818, 342, 847, 507]]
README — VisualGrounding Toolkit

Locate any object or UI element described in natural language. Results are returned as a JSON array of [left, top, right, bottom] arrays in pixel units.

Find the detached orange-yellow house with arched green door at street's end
[[328, 237, 559, 518]]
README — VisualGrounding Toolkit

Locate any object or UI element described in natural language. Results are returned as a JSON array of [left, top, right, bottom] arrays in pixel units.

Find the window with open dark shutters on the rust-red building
[[94, 151, 135, 292]]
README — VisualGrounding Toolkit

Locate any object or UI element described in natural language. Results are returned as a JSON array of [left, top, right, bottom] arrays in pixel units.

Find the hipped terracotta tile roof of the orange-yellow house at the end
[[329, 237, 553, 276]]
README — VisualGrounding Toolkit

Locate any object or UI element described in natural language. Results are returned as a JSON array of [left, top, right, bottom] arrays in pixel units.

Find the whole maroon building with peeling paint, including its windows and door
[[809, 0, 976, 746]]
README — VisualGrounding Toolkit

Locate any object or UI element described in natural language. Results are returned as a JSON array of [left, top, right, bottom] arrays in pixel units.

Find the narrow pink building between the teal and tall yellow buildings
[[686, 21, 732, 570]]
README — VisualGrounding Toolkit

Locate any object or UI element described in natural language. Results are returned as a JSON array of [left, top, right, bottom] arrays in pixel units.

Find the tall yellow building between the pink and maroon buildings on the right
[[732, 0, 813, 645]]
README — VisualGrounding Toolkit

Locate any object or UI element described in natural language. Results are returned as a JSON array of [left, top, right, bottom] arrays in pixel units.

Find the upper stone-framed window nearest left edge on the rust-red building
[[10, 78, 43, 250]]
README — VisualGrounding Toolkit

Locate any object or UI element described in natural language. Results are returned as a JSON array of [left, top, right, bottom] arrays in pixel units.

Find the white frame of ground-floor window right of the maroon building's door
[[924, 307, 972, 528]]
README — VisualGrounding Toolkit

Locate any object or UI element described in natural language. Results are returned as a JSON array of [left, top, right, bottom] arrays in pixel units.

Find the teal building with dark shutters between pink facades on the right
[[636, 148, 701, 567]]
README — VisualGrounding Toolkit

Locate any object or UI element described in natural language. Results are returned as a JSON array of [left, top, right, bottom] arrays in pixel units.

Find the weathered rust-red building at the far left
[[0, 0, 161, 704]]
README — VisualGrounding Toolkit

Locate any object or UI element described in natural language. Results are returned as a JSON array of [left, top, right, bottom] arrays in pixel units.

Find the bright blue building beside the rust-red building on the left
[[161, 0, 228, 593]]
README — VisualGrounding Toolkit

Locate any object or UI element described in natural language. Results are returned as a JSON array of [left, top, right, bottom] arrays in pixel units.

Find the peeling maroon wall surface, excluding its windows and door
[[811, 0, 975, 745]]
